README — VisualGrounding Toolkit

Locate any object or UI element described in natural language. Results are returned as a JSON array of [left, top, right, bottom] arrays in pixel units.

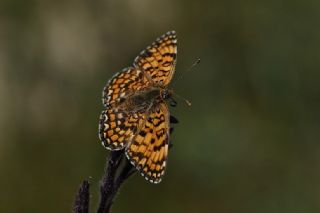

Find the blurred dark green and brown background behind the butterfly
[[0, 0, 320, 213]]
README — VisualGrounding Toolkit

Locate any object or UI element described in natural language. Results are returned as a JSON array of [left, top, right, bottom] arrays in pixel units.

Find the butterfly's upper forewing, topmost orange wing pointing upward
[[134, 31, 177, 86]]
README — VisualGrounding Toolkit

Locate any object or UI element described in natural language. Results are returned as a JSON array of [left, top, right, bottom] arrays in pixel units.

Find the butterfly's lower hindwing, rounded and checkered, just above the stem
[[99, 108, 146, 150]]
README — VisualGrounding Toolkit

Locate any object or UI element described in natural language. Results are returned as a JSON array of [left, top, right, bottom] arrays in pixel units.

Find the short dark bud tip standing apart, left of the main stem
[[73, 180, 90, 213]]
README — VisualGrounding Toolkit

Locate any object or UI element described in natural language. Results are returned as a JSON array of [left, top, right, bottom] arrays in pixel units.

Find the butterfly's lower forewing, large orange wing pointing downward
[[126, 103, 170, 183]]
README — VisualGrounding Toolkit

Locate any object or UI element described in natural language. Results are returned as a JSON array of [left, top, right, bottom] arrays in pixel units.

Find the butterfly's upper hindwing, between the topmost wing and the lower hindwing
[[102, 67, 150, 107]]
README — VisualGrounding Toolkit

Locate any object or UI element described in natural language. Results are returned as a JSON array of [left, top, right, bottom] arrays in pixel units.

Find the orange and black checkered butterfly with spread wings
[[99, 31, 177, 183]]
